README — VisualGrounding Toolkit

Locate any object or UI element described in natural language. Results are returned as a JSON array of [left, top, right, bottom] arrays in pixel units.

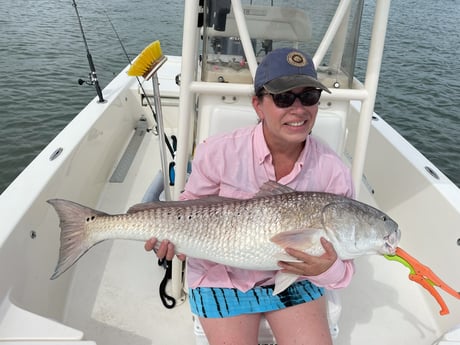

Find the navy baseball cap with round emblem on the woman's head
[[254, 48, 331, 94]]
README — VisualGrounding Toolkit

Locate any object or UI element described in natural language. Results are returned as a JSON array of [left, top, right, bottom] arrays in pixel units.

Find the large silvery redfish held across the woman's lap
[[48, 182, 401, 293]]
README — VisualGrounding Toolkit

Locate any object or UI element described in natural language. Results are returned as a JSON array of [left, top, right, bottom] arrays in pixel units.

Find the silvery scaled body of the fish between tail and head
[[90, 193, 317, 269]]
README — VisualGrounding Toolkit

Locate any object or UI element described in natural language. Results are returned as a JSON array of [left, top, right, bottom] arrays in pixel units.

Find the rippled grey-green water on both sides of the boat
[[0, 0, 460, 192]]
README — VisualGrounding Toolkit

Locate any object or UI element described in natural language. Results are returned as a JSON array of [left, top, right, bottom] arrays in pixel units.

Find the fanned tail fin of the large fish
[[47, 199, 106, 279]]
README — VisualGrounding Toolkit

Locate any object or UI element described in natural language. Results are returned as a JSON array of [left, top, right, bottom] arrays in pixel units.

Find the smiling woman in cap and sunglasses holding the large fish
[[145, 48, 354, 345]]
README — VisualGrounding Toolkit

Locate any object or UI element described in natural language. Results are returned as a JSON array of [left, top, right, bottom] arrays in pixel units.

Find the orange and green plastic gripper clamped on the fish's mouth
[[384, 247, 460, 315]]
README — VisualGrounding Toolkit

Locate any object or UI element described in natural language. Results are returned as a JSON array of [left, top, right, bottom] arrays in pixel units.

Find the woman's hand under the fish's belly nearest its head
[[278, 237, 337, 276]]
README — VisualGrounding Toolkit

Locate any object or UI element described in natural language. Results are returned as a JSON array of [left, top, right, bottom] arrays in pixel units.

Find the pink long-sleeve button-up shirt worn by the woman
[[180, 124, 354, 291]]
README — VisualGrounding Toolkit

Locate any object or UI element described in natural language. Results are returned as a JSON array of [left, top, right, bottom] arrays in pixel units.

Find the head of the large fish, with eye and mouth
[[322, 199, 401, 259]]
